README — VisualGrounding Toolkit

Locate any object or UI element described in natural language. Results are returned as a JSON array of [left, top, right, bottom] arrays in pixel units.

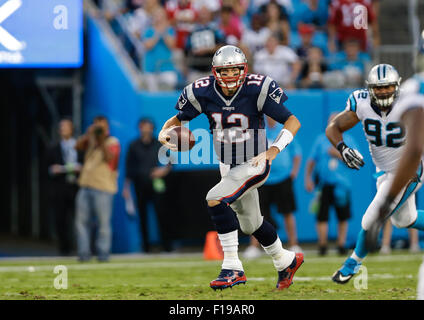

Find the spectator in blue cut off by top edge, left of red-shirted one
[[290, 0, 328, 31]]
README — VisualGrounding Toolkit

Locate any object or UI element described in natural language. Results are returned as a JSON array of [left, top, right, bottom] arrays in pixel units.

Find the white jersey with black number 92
[[346, 89, 406, 172]]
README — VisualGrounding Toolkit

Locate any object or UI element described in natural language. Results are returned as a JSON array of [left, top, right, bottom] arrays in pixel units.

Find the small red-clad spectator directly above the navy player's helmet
[[219, 5, 243, 46]]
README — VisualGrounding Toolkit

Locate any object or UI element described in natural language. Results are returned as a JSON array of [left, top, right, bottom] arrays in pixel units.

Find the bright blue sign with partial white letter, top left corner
[[0, 0, 83, 68]]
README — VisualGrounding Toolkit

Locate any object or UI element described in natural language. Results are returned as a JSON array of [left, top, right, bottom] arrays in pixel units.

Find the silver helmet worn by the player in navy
[[212, 45, 247, 89]]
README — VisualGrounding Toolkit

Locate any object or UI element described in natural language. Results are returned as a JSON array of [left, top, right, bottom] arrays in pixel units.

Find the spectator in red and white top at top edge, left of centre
[[166, 0, 197, 49]]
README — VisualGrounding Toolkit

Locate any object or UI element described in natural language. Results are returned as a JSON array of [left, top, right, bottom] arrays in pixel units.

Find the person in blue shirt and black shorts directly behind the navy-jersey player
[[244, 117, 302, 259]]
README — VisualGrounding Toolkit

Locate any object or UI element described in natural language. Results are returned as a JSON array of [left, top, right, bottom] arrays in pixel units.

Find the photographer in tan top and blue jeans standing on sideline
[[75, 116, 120, 262]]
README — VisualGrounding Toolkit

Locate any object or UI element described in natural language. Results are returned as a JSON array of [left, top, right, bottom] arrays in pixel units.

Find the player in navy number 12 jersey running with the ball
[[159, 45, 303, 290]]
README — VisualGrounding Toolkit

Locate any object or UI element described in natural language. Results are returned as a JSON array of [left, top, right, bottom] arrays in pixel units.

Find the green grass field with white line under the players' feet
[[0, 251, 422, 300]]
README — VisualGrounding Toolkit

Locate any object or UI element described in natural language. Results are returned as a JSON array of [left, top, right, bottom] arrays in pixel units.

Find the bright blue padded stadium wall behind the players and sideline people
[[83, 18, 424, 253]]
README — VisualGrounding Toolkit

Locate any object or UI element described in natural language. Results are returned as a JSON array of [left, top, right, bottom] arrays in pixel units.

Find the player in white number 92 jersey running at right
[[326, 64, 424, 283]]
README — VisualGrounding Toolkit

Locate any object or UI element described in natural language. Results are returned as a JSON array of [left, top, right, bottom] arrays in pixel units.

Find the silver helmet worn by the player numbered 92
[[365, 64, 402, 109]]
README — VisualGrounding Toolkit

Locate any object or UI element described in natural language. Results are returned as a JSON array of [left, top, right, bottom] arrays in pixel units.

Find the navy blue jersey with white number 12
[[175, 74, 292, 165]]
